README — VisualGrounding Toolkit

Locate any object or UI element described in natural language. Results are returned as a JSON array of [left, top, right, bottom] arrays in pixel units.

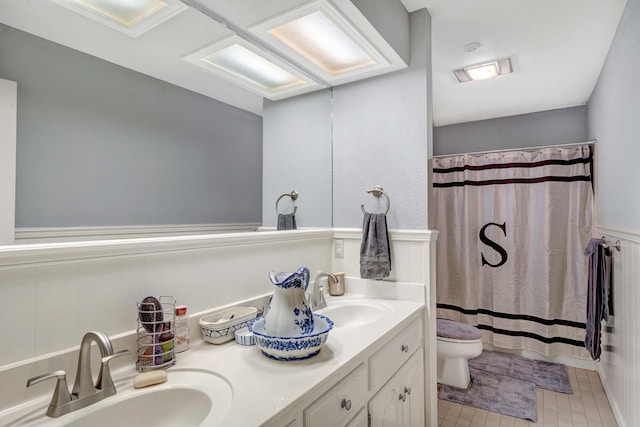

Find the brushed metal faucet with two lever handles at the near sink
[[27, 331, 129, 418]]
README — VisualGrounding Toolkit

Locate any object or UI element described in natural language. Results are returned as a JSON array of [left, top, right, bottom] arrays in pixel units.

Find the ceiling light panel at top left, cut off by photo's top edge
[[52, 0, 187, 37]]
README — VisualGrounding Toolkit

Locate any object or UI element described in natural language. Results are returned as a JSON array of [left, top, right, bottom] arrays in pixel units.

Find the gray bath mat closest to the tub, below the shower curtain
[[469, 350, 573, 393]]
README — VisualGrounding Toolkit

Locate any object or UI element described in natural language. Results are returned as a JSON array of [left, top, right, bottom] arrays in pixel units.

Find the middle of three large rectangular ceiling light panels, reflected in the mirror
[[184, 36, 319, 100]]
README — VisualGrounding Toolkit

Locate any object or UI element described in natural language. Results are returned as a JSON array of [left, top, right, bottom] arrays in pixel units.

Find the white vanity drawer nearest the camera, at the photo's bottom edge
[[304, 363, 367, 427]]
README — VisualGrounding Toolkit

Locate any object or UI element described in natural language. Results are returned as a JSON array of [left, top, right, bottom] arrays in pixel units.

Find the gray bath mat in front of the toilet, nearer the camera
[[438, 368, 538, 422]]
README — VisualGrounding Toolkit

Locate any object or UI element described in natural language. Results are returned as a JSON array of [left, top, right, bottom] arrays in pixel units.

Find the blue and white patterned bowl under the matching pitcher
[[249, 314, 333, 361]]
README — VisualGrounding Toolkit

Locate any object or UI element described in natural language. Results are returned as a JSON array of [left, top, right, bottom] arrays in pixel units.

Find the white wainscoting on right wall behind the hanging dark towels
[[597, 226, 640, 427]]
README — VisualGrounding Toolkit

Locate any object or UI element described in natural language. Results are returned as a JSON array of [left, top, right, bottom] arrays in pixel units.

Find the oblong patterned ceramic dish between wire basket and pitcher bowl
[[198, 307, 258, 344]]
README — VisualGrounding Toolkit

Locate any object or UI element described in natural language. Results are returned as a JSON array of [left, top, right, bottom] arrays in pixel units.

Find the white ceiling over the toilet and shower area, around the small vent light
[[412, 0, 627, 126]]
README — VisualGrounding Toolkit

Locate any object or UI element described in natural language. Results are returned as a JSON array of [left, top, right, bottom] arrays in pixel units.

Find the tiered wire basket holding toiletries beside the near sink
[[136, 296, 176, 372]]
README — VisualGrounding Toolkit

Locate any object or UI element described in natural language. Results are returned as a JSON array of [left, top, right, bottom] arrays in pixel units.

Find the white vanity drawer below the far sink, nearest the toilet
[[369, 318, 422, 390]]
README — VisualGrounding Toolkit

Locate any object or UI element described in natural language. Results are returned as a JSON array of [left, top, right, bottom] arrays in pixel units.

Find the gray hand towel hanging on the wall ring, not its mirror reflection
[[360, 212, 391, 280]]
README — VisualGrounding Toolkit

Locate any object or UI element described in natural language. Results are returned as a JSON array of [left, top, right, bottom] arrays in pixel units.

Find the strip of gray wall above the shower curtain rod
[[433, 105, 588, 156]]
